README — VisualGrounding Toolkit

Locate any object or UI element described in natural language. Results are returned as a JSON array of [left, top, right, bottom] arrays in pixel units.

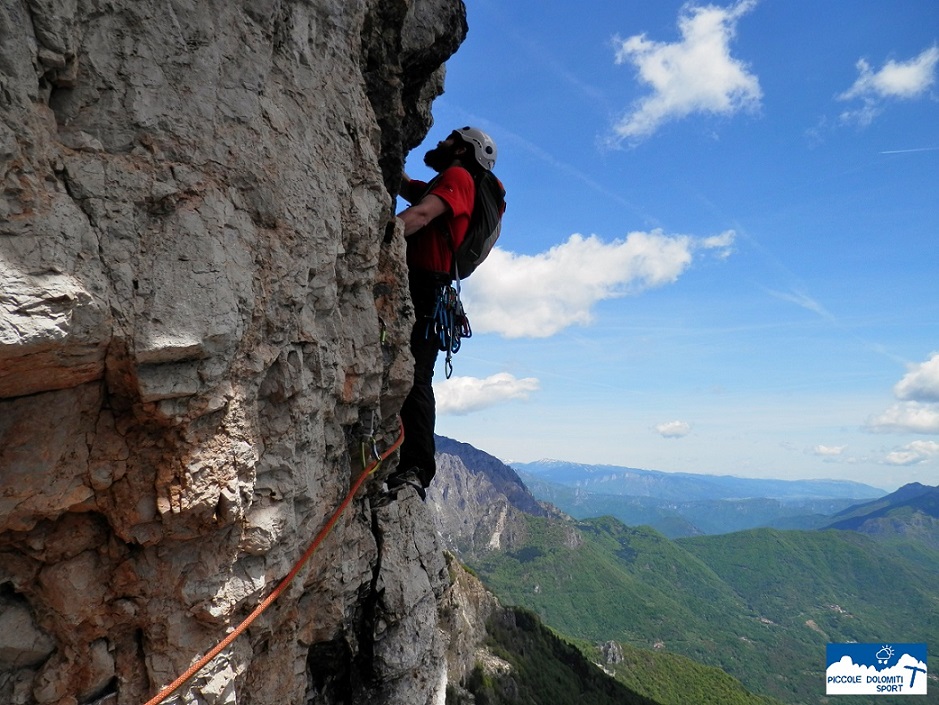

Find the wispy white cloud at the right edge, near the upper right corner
[[837, 46, 939, 125]]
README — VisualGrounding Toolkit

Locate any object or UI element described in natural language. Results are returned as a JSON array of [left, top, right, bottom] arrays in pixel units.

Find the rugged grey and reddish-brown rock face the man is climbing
[[0, 0, 466, 705]]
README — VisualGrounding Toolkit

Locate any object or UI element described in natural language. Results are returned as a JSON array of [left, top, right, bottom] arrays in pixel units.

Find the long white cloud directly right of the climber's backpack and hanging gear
[[463, 230, 734, 338]]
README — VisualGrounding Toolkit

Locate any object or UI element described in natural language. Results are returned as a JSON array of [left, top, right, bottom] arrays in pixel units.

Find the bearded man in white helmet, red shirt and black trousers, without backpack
[[387, 127, 496, 499]]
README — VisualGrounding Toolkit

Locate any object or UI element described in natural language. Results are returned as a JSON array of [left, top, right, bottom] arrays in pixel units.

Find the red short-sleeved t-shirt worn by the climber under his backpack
[[407, 166, 476, 274]]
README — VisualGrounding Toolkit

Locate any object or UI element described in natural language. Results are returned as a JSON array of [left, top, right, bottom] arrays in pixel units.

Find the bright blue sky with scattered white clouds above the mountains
[[407, 0, 939, 489]]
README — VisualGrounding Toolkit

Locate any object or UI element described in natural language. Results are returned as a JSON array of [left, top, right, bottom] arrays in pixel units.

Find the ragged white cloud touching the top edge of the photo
[[613, 0, 762, 142]]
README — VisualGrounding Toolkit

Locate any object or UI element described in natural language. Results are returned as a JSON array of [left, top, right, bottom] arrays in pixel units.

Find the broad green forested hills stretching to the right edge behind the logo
[[465, 517, 939, 705]]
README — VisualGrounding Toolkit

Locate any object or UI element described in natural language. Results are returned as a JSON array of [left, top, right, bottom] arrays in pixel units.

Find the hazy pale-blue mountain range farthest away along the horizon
[[512, 460, 886, 538]]
